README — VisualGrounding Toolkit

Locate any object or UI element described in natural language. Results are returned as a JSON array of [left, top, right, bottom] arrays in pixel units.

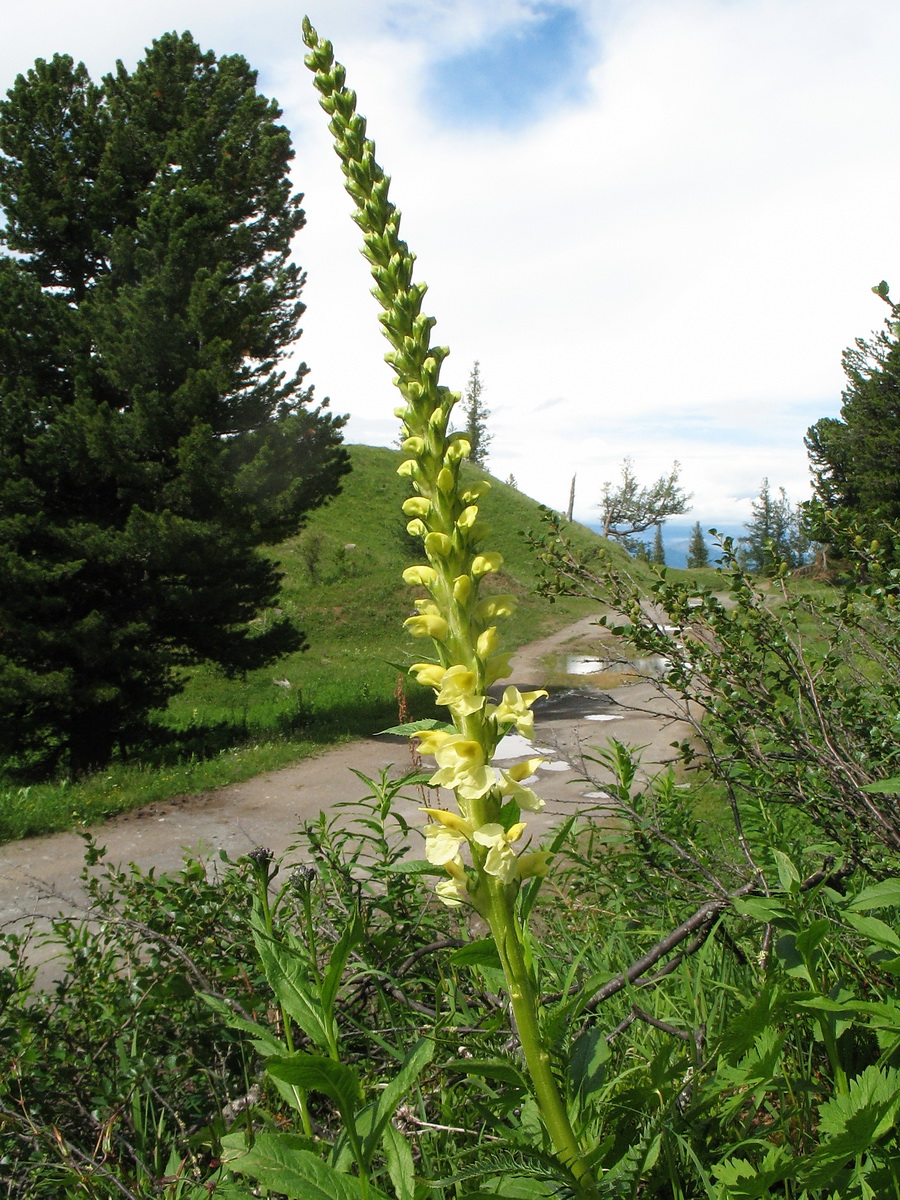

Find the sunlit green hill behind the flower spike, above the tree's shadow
[[170, 446, 619, 737]]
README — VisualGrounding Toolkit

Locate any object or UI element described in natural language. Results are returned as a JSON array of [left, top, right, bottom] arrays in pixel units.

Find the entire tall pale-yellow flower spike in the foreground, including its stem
[[304, 19, 594, 1196]]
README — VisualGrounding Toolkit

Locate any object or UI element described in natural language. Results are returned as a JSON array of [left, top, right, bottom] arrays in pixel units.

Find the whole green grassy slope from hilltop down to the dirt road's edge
[[0, 446, 619, 840]]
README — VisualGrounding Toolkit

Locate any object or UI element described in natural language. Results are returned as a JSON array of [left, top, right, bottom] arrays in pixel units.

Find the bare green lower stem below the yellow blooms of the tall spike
[[485, 880, 595, 1196]]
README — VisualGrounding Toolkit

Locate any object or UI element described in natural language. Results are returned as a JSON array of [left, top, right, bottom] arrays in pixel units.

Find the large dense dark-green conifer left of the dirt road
[[0, 34, 349, 773]]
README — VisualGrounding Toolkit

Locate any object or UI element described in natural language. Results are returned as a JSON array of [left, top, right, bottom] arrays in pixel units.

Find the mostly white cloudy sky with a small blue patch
[[7, 0, 900, 526]]
